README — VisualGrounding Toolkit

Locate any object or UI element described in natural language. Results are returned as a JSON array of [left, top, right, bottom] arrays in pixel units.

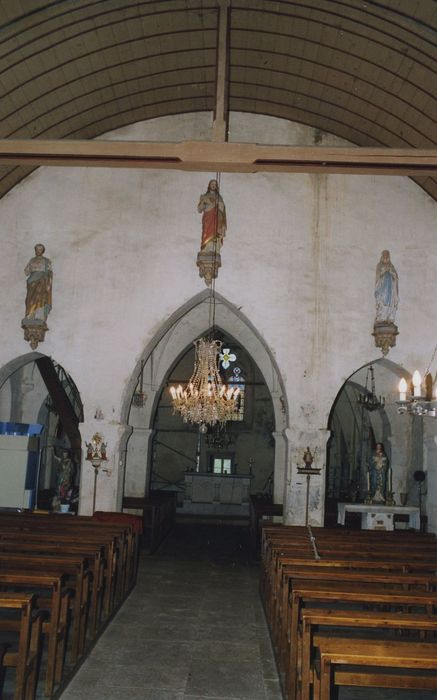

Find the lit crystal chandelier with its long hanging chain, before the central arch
[[170, 173, 240, 433]]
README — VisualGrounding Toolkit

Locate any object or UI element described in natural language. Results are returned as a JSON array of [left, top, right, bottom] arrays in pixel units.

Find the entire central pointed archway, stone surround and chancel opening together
[[124, 291, 286, 520]]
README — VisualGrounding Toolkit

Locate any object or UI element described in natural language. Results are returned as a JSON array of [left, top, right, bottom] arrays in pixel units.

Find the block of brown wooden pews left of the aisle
[[0, 512, 140, 700]]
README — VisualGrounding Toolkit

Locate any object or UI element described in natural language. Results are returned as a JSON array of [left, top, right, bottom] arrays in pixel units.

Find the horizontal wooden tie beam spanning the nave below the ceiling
[[0, 139, 437, 177]]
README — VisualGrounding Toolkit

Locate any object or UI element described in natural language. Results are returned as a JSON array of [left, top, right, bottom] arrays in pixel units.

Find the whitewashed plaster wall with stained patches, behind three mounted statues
[[0, 113, 437, 529]]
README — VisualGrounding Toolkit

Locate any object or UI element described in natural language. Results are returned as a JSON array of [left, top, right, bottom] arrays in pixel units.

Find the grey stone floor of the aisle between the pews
[[50, 524, 436, 700]]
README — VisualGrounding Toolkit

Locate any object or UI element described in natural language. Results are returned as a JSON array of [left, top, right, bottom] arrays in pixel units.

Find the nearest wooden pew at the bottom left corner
[[0, 592, 43, 700]]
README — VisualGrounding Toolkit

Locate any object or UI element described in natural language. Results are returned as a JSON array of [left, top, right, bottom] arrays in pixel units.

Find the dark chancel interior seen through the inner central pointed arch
[[149, 329, 275, 519]]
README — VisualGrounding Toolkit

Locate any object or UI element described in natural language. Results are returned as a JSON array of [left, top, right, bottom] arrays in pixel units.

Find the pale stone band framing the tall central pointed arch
[[119, 290, 288, 504]]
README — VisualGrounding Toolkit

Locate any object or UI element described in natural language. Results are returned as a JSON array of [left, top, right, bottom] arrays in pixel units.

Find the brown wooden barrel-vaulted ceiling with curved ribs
[[0, 0, 437, 199]]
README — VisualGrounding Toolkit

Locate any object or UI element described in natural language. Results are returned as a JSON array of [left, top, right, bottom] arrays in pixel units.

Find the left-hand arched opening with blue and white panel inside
[[0, 353, 83, 512]]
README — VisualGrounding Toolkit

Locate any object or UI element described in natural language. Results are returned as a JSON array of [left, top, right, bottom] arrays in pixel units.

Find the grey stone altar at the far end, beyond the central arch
[[183, 472, 253, 515]]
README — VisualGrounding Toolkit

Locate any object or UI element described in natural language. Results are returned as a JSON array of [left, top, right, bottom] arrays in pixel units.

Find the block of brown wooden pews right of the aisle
[[260, 525, 437, 700]]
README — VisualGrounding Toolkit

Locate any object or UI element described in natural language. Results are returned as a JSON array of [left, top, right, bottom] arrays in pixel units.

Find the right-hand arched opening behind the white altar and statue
[[325, 359, 423, 526]]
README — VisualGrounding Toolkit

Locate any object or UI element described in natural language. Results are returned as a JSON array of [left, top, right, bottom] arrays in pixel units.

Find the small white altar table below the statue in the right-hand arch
[[337, 503, 420, 530]]
